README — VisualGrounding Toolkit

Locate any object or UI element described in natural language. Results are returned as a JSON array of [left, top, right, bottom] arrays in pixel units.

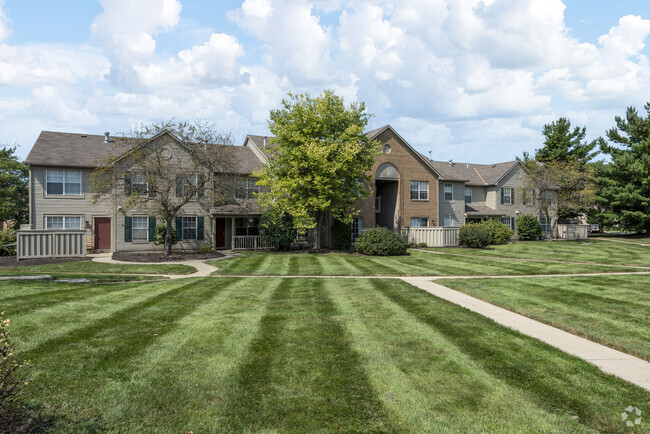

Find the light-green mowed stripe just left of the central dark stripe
[[91, 278, 281, 432]]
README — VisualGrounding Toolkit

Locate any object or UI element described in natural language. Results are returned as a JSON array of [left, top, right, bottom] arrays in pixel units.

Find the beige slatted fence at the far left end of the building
[[16, 230, 86, 260]]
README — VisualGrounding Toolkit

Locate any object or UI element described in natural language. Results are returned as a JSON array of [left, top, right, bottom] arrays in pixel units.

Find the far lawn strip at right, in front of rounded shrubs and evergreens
[[431, 238, 650, 267]]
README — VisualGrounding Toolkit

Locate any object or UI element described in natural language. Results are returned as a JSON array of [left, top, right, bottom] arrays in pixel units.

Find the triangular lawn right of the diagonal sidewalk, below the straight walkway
[[440, 275, 650, 360]]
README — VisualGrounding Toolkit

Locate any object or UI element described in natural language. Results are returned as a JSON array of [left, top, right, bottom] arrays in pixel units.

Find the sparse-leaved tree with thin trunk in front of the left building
[[91, 121, 235, 255]]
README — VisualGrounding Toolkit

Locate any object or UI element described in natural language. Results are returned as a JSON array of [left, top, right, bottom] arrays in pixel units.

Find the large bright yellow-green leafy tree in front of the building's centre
[[257, 90, 379, 249]]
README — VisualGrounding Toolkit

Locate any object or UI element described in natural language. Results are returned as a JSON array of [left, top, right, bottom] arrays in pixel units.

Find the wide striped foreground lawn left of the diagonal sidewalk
[[0, 278, 650, 432]]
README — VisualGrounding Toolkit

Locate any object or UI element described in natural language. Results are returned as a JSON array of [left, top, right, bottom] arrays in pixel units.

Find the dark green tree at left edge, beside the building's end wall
[[0, 147, 29, 227]]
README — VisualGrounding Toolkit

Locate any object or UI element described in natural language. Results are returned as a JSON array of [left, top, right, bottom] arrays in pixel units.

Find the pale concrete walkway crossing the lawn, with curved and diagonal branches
[[87, 251, 650, 391]]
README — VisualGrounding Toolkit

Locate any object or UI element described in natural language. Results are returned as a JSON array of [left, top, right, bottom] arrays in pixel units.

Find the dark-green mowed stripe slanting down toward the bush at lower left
[[21, 278, 223, 416]]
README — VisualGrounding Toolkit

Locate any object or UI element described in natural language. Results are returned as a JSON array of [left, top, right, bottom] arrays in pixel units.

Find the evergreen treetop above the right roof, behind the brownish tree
[[535, 118, 598, 166]]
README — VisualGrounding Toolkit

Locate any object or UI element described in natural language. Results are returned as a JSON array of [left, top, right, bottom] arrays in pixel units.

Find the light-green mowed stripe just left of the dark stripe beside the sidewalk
[[330, 280, 586, 432]]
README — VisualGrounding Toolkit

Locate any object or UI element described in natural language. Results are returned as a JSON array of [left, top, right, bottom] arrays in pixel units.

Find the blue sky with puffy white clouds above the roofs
[[0, 0, 650, 163]]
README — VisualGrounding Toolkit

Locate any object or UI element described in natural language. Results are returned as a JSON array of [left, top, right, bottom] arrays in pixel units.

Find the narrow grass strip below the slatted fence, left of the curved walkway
[[0, 261, 196, 276]]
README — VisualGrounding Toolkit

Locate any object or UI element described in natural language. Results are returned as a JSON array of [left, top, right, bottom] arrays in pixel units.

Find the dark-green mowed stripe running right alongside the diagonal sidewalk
[[364, 281, 650, 432]]
